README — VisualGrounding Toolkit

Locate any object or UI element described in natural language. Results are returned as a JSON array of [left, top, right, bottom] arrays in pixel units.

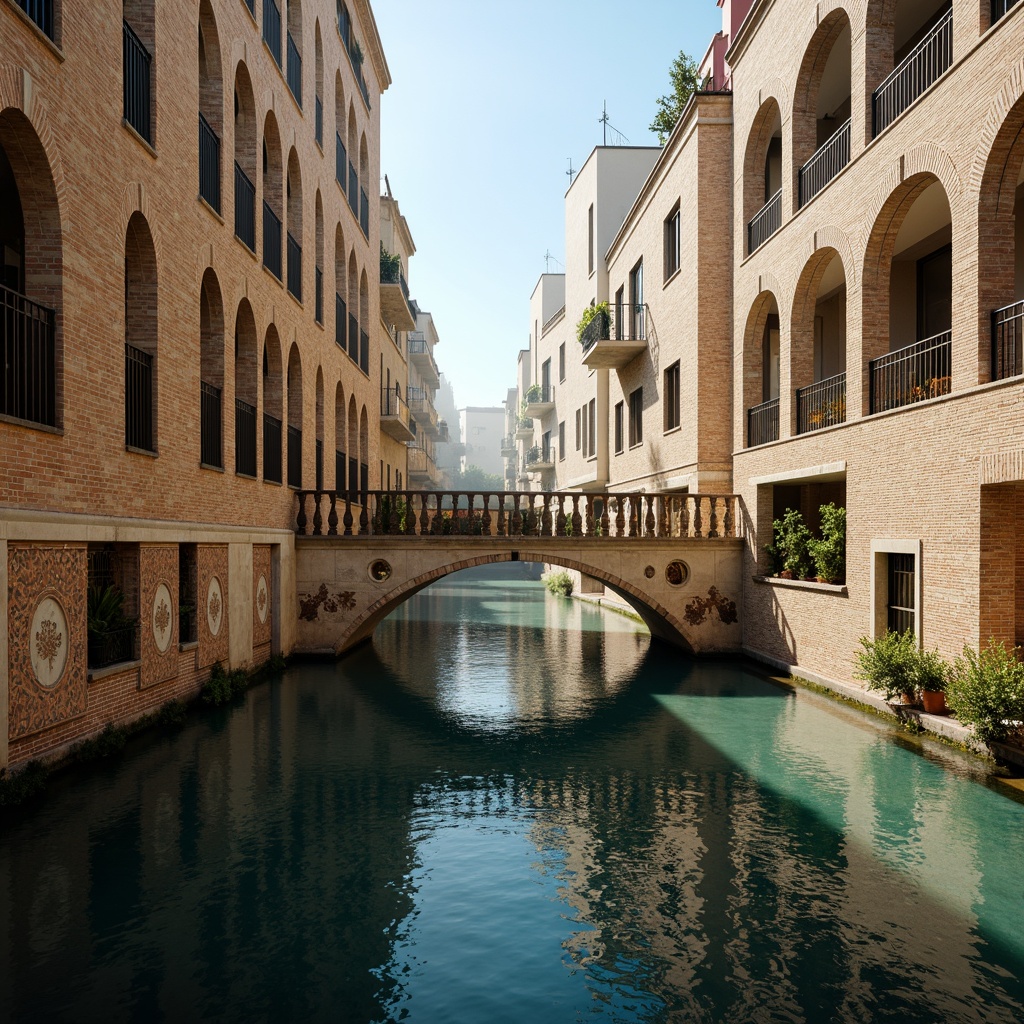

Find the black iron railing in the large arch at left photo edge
[[0, 285, 57, 427]]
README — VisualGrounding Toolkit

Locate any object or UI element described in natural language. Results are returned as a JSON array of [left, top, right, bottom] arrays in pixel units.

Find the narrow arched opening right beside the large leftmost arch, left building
[[125, 212, 159, 452]]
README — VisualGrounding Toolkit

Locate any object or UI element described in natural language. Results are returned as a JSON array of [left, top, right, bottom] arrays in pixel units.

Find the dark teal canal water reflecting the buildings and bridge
[[0, 574, 1024, 1024]]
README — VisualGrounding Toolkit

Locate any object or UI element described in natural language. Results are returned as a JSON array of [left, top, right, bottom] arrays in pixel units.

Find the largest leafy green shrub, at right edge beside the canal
[[946, 640, 1024, 742]]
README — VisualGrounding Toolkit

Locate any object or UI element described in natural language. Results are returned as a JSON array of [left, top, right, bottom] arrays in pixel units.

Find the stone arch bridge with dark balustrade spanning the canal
[[295, 490, 743, 655]]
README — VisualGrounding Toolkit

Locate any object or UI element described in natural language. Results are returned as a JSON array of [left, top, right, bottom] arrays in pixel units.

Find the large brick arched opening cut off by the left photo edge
[[0, 108, 63, 427]]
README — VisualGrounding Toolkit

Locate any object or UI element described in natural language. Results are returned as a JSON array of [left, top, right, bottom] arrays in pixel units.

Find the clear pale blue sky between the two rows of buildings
[[373, 0, 721, 407]]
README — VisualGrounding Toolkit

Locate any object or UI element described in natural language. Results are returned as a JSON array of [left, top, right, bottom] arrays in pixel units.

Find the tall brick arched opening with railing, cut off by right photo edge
[[978, 88, 1024, 381]]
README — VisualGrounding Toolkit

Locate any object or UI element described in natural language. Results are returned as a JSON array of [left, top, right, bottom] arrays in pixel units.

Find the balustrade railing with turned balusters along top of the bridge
[[295, 490, 736, 543]]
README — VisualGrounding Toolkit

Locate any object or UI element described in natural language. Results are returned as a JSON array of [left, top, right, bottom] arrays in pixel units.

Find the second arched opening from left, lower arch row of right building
[[790, 248, 846, 434]]
